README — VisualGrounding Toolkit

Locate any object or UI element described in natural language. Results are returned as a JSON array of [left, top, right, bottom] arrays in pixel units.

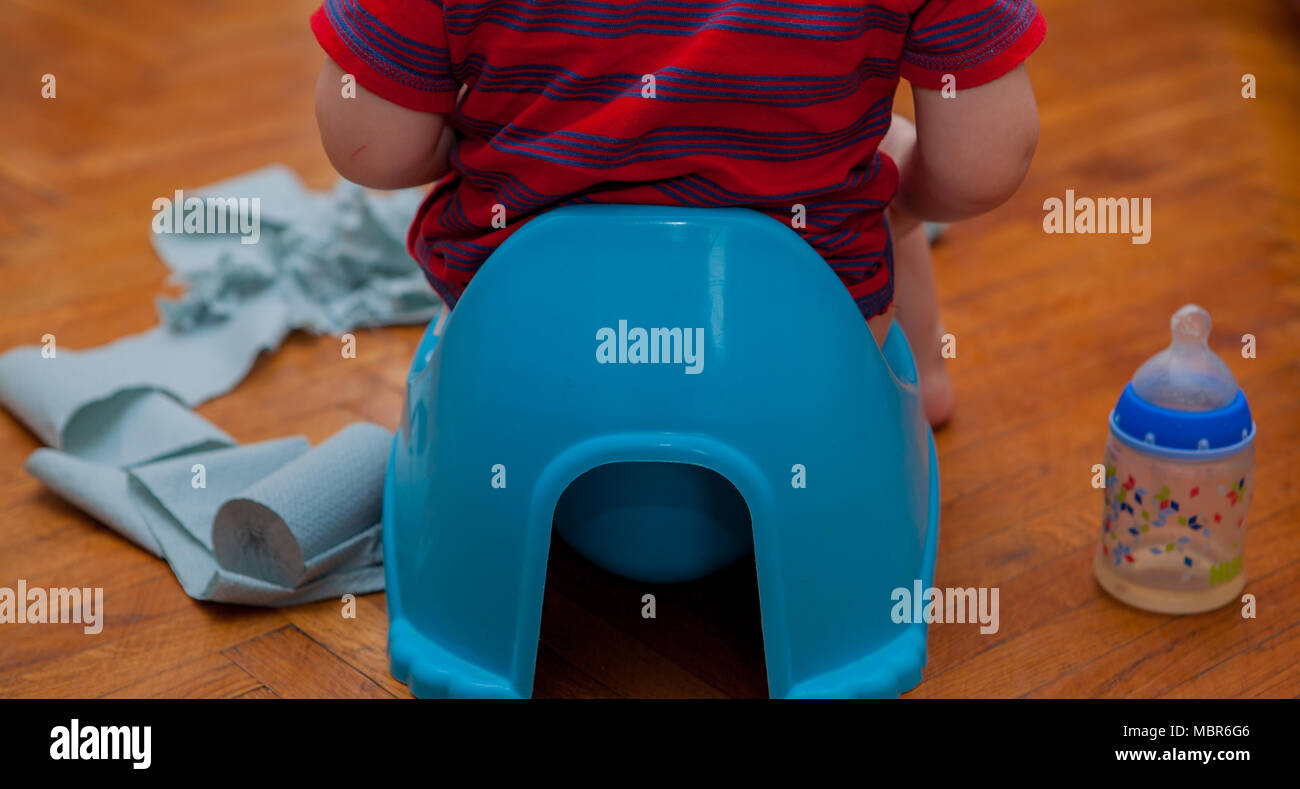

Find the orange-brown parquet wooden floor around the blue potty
[[0, 0, 1300, 698]]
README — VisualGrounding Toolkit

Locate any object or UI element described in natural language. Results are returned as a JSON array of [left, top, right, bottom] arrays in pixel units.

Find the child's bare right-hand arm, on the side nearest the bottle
[[894, 65, 1039, 233]]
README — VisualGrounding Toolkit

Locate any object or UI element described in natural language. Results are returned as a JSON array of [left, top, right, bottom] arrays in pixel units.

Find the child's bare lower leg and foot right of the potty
[[889, 222, 954, 428]]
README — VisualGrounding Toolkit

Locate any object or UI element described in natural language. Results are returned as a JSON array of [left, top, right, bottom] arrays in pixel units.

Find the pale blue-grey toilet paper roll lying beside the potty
[[212, 422, 393, 586]]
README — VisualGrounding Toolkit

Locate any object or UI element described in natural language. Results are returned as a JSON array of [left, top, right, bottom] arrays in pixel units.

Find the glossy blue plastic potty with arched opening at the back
[[384, 205, 939, 698]]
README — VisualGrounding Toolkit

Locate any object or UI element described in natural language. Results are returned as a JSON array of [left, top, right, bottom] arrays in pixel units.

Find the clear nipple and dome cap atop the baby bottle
[[1134, 304, 1238, 411]]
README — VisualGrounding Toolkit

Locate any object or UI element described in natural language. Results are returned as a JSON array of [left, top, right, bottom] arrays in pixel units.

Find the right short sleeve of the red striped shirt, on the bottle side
[[900, 0, 1048, 90]]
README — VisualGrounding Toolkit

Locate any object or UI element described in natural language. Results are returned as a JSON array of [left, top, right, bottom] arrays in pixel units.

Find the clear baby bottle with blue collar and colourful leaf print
[[1093, 304, 1255, 614]]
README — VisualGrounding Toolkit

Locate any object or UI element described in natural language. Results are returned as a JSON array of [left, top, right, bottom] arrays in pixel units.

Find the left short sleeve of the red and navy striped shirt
[[311, 0, 460, 112]]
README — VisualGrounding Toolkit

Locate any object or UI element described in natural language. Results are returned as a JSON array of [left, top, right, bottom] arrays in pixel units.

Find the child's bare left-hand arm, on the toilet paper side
[[316, 60, 454, 188]]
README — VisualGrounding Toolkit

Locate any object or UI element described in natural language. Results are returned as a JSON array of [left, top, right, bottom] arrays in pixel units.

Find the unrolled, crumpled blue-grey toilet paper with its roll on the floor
[[0, 166, 445, 606]]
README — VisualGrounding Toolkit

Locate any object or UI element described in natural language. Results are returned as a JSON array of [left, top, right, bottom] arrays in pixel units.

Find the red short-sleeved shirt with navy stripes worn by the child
[[312, 0, 1047, 317]]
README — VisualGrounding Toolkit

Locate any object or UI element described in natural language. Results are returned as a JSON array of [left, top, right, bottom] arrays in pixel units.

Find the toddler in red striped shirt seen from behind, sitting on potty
[[311, 0, 1047, 425]]
